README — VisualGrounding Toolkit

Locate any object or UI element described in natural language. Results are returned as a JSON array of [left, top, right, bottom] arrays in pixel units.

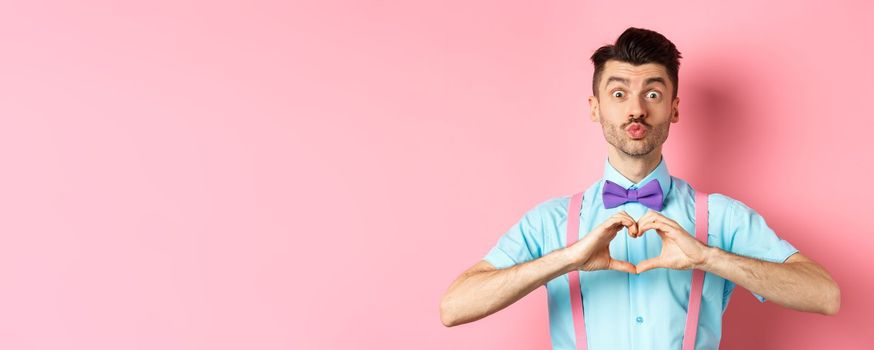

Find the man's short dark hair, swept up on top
[[592, 27, 682, 98]]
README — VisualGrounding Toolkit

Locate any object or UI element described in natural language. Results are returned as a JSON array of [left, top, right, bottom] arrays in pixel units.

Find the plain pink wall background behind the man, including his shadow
[[0, 0, 874, 349]]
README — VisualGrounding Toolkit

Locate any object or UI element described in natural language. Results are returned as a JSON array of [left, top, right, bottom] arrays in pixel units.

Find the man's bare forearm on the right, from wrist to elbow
[[699, 247, 840, 315]]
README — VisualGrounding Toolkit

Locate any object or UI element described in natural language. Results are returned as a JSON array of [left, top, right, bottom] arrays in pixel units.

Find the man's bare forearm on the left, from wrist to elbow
[[440, 249, 573, 326]]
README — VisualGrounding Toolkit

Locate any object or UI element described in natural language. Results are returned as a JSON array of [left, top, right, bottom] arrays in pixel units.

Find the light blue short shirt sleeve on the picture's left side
[[483, 205, 543, 269]]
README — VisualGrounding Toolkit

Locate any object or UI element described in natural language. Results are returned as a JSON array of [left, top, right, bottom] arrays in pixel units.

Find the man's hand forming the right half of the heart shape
[[631, 210, 707, 273]]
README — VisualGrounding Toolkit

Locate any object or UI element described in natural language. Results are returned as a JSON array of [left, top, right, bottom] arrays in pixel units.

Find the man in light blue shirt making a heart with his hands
[[440, 28, 840, 350]]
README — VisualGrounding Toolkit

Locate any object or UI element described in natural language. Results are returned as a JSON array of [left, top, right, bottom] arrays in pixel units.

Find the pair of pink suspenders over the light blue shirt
[[567, 192, 707, 350]]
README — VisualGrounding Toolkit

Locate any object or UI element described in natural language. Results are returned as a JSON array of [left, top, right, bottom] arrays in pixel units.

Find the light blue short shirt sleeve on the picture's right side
[[726, 200, 798, 302]]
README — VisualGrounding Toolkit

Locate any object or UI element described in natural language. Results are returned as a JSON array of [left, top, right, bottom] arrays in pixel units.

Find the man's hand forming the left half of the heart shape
[[568, 211, 639, 273]]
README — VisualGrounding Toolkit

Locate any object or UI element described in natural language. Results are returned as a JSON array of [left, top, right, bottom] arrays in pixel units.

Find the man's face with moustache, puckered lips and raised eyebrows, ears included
[[589, 60, 680, 157]]
